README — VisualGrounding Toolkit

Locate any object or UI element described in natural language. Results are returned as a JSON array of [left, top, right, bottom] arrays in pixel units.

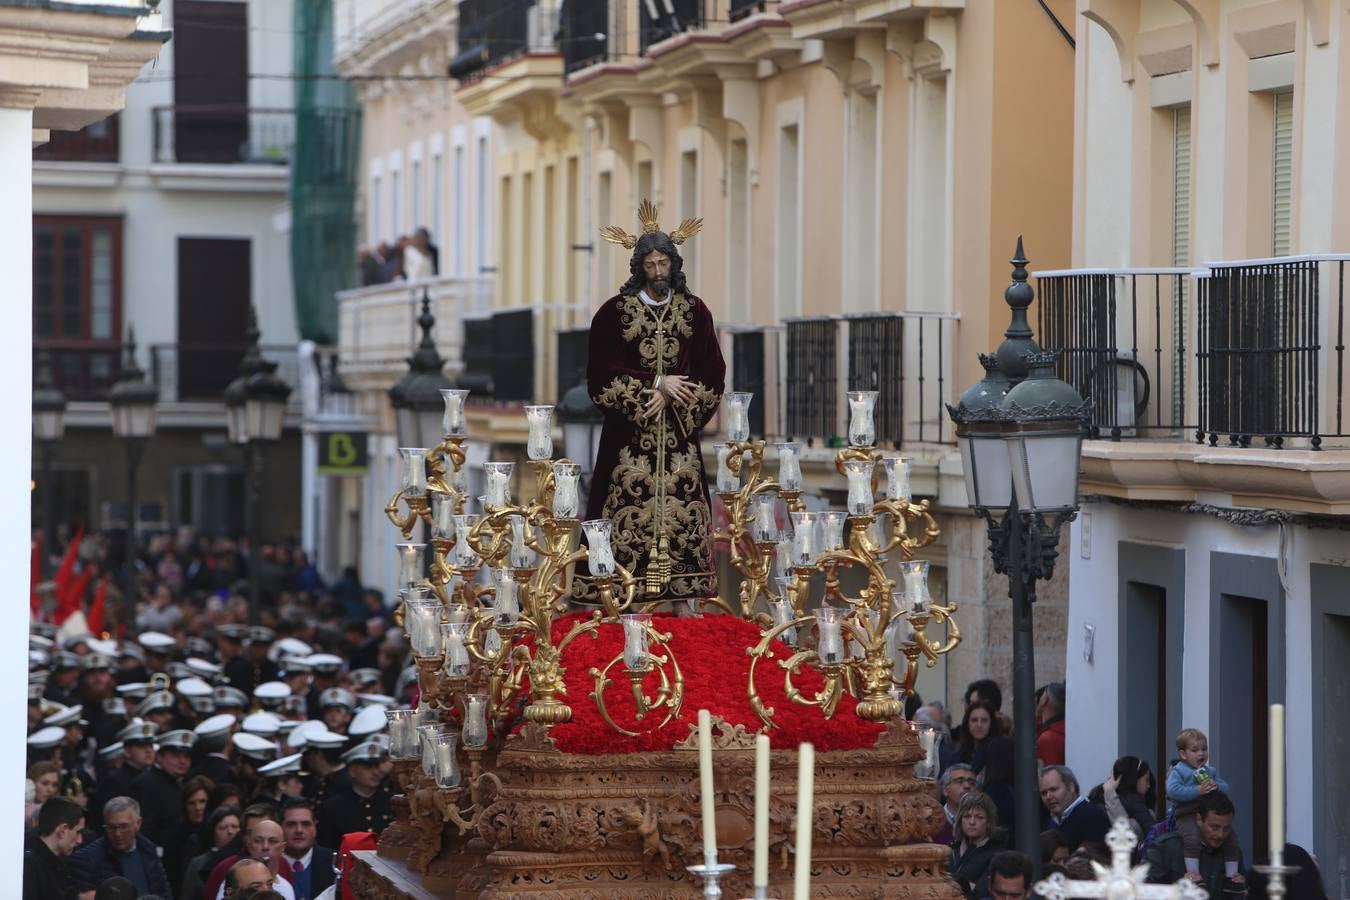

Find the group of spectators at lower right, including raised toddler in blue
[[913, 679, 1327, 900]]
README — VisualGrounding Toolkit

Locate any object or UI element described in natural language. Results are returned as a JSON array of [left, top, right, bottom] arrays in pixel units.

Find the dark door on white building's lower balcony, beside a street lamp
[[176, 237, 252, 401]]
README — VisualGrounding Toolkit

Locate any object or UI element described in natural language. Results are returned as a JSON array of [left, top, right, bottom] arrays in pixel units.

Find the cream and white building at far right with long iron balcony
[[1033, 0, 1350, 896]]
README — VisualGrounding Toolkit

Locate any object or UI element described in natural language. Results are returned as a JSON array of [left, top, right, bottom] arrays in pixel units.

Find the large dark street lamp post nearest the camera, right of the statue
[[948, 237, 1089, 870]]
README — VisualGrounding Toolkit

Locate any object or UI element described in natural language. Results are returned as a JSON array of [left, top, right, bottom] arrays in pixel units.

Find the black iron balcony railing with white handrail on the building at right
[[1037, 254, 1350, 449]]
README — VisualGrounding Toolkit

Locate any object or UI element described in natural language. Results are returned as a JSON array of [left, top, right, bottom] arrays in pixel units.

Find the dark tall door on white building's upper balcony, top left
[[173, 0, 250, 163]]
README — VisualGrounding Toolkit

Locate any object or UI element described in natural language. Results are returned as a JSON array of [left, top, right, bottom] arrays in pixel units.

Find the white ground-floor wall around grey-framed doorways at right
[[1065, 503, 1347, 853]]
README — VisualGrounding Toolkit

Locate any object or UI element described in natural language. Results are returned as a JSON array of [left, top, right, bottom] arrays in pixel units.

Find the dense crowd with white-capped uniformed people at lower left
[[23, 533, 402, 900]]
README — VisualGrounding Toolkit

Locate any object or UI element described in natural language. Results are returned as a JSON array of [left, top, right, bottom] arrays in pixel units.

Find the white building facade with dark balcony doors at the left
[[32, 0, 300, 538]]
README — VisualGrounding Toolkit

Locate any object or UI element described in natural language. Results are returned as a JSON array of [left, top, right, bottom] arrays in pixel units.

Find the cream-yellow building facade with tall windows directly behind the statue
[[339, 0, 1076, 696]]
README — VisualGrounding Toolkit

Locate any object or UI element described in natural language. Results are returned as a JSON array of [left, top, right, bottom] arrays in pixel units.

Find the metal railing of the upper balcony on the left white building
[[151, 105, 296, 166]]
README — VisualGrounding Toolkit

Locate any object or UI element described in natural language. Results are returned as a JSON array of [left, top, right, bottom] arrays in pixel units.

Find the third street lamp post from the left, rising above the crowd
[[225, 306, 290, 625]]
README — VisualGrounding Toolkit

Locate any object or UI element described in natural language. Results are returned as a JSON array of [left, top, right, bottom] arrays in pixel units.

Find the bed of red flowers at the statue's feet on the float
[[537, 613, 882, 753]]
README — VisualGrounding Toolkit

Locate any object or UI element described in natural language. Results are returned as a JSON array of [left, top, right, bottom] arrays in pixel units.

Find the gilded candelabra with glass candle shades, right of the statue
[[717, 391, 961, 727]]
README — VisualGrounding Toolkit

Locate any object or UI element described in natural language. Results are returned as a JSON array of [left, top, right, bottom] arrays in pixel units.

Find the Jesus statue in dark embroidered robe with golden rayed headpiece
[[586, 200, 726, 603]]
